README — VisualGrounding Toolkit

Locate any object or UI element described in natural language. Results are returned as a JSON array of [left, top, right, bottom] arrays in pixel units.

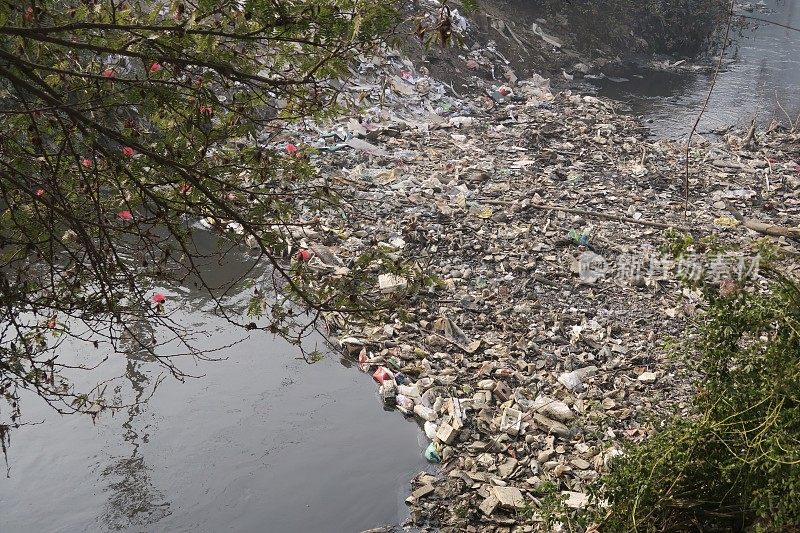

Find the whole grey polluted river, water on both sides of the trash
[[0, 0, 800, 532]]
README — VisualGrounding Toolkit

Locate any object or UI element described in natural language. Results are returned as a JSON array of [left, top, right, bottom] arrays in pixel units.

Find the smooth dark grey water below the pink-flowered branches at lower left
[[0, 234, 427, 533]]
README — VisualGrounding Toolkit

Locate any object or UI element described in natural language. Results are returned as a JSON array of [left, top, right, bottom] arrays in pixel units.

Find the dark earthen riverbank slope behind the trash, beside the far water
[[396, 0, 728, 94]]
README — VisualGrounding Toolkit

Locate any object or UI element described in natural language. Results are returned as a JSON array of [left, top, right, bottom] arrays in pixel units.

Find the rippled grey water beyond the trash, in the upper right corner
[[592, 0, 800, 137]]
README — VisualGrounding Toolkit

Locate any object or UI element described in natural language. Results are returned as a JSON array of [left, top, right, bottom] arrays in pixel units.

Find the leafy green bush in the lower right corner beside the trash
[[596, 270, 800, 532]]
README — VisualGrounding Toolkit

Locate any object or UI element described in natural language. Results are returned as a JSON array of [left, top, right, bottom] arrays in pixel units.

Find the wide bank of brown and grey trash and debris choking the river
[[274, 47, 800, 531]]
